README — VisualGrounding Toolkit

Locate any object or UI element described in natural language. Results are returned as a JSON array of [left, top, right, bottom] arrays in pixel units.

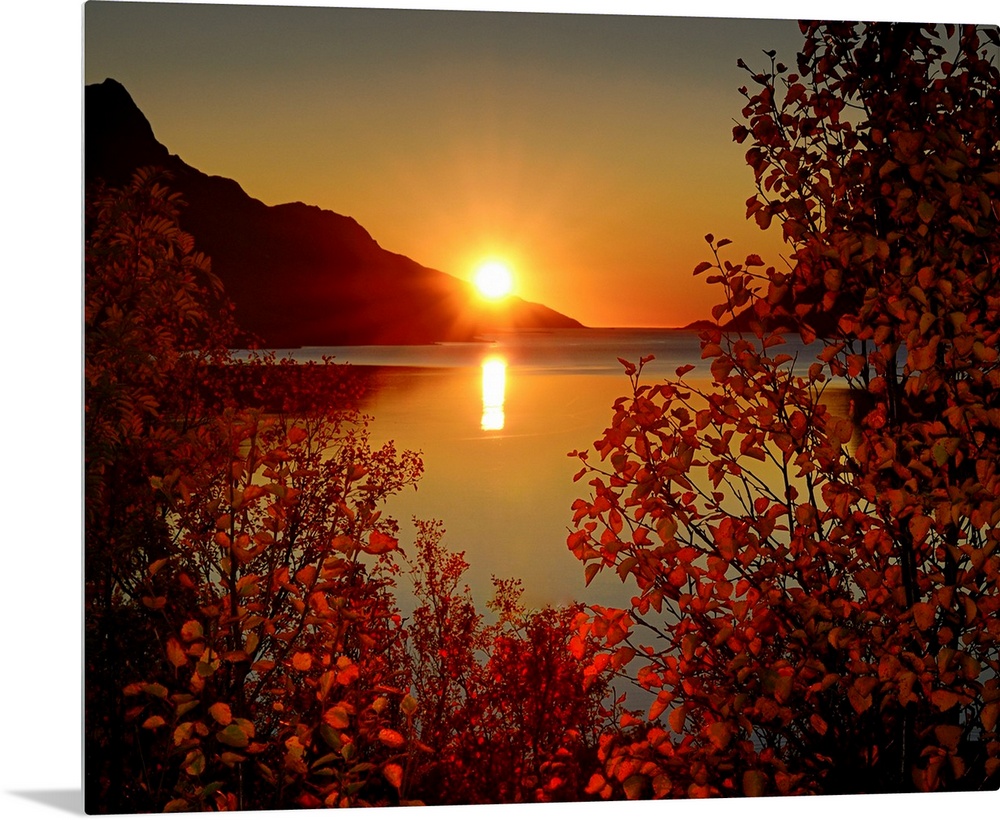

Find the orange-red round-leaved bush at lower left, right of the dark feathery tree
[[126, 412, 420, 809]]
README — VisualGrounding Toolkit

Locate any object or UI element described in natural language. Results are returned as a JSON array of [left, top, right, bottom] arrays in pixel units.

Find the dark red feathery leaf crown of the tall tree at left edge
[[84, 170, 232, 600]]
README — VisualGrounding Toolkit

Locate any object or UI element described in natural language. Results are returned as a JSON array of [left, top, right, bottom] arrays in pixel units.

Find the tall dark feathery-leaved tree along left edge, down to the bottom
[[84, 169, 233, 810]]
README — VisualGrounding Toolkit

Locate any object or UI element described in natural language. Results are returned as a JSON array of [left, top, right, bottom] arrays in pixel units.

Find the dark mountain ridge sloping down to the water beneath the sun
[[84, 79, 582, 347]]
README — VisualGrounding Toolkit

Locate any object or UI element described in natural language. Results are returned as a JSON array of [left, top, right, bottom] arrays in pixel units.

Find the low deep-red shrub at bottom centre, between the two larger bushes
[[408, 521, 609, 804]]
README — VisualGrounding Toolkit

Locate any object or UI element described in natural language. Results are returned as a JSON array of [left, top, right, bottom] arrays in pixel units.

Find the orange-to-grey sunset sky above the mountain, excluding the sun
[[84, 2, 960, 326]]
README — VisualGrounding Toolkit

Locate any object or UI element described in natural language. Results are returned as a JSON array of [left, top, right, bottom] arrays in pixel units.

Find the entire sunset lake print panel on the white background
[[83, 0, 1000, 814]]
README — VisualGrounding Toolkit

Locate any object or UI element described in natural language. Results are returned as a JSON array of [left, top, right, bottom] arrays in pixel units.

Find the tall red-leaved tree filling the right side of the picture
[[569, 23, 1000, 797]]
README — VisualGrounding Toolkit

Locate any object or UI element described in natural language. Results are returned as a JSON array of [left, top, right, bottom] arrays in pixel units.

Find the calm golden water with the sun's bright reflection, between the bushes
[[278, 329, 824, 606]]
